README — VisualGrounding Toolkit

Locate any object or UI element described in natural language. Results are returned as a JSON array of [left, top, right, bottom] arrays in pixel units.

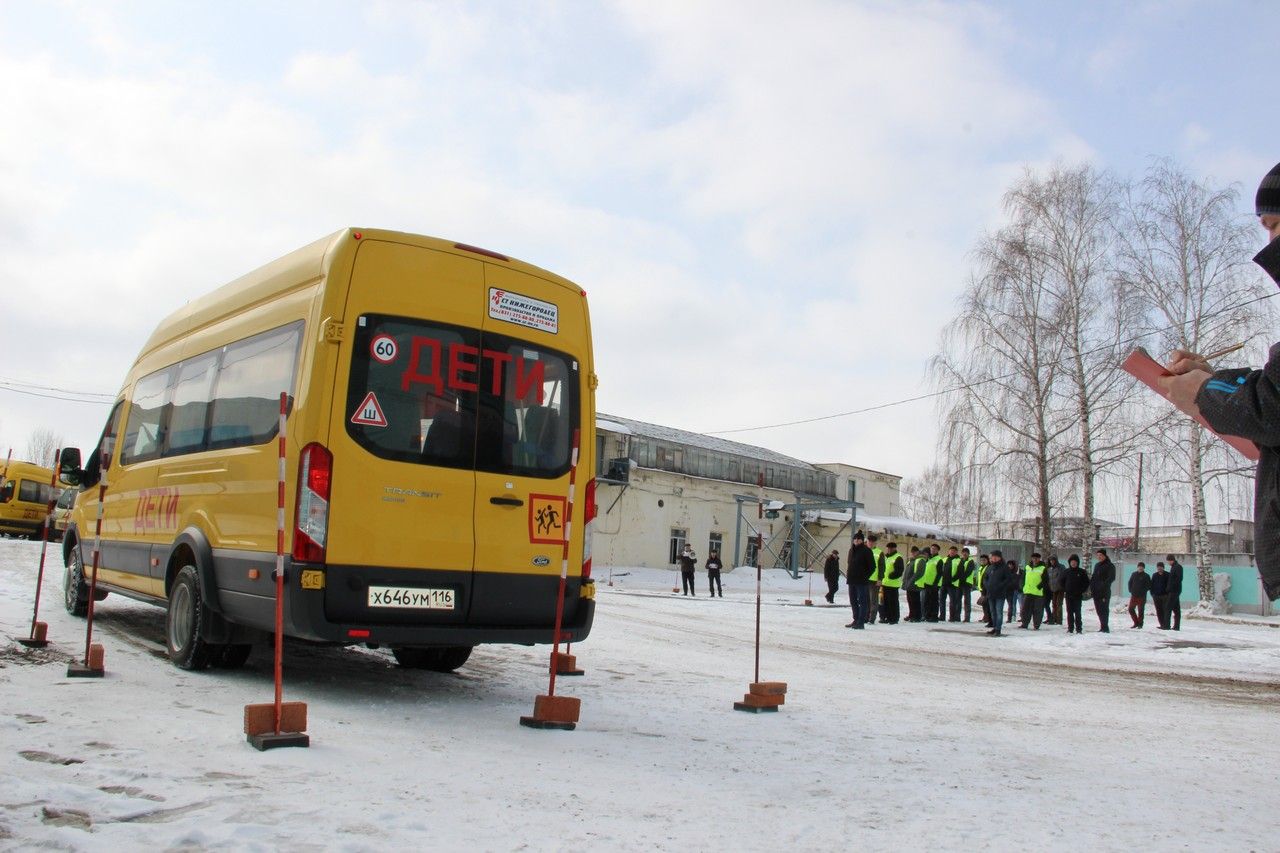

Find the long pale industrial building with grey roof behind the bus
[[593, 414, 945, 571]]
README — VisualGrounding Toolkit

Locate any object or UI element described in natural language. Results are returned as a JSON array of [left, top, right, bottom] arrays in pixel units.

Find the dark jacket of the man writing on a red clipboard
[[1192, 343, 1280, 601]]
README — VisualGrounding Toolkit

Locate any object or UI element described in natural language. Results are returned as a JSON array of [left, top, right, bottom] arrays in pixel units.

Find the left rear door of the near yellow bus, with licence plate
[[325, 240, 484, 624]]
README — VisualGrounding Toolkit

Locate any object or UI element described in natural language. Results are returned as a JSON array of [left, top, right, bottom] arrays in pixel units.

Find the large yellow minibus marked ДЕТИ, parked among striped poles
[[60, 229, 596, 671]]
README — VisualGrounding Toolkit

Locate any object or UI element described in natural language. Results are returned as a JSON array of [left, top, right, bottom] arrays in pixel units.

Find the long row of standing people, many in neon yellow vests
[[823, 530, 1183, 637]]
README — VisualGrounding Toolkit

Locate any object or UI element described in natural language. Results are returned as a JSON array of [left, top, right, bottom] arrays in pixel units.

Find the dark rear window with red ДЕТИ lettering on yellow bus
[[347, 315, 579, 478]]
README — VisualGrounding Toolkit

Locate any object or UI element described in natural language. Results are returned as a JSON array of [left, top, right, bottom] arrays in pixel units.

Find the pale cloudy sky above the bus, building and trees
[[0, 0, 1280, 511]]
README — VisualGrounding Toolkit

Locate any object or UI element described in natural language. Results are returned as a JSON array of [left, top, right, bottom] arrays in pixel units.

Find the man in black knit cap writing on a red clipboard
[[1157, 164, 1280, 601]]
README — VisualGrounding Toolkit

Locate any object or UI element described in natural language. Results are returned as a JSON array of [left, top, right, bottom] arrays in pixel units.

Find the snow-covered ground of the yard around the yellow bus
[[0, 539, 1280, 850]]
